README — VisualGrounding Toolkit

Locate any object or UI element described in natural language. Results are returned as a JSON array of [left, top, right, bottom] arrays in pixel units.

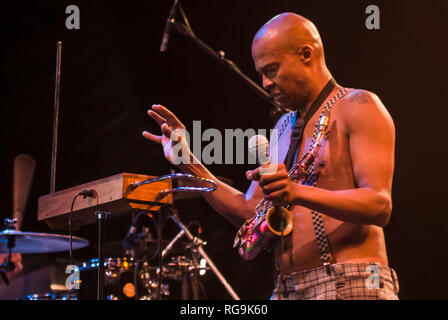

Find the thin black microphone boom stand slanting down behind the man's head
[[163, 0, 292, 119]]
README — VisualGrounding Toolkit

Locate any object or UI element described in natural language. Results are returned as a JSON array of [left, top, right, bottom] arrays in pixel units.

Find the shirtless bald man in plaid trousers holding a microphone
[[143, 13, 398, 299]]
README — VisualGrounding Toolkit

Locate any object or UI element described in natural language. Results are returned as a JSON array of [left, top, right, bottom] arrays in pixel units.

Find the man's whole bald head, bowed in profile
[[252, 13, 331, 109]]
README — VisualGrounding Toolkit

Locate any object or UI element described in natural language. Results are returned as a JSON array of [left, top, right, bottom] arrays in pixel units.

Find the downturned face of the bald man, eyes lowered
[[252, 41, 307, 108]]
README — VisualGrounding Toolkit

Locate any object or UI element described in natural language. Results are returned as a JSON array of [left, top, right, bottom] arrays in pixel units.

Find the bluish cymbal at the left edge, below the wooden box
[[0, 229, 89, 253]]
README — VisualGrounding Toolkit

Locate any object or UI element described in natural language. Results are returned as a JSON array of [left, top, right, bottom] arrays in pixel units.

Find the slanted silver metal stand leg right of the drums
[[164, 214, 241, 300]]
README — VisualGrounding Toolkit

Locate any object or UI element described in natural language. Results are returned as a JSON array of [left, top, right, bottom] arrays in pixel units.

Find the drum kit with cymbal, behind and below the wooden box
[[0, 204, 216, 300]]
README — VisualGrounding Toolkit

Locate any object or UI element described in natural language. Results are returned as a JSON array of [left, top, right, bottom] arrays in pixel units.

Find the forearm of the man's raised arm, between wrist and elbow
[[178, 159, 254, 227]]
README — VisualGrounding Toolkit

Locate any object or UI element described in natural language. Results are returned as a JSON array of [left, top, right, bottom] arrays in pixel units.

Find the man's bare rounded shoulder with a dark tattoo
[[338, 89, 395, 132]]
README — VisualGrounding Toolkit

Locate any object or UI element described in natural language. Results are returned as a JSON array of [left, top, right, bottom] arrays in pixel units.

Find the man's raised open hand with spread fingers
[[142, 104, 191, 165]]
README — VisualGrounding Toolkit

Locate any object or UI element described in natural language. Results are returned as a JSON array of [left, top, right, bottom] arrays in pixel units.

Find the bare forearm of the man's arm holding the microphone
[[294, 185, 392, 227]]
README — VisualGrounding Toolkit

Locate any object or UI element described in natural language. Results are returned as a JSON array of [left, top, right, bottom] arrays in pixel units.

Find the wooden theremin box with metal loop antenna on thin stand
[[38, 173, 208, 300]]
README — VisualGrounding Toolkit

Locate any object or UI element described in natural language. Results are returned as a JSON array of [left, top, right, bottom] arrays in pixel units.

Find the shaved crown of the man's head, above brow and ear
[[252, 12, 324, 59]]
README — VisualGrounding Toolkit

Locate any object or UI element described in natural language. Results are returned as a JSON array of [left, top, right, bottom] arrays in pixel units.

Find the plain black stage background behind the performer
[[0, 0, 448, 299]]
